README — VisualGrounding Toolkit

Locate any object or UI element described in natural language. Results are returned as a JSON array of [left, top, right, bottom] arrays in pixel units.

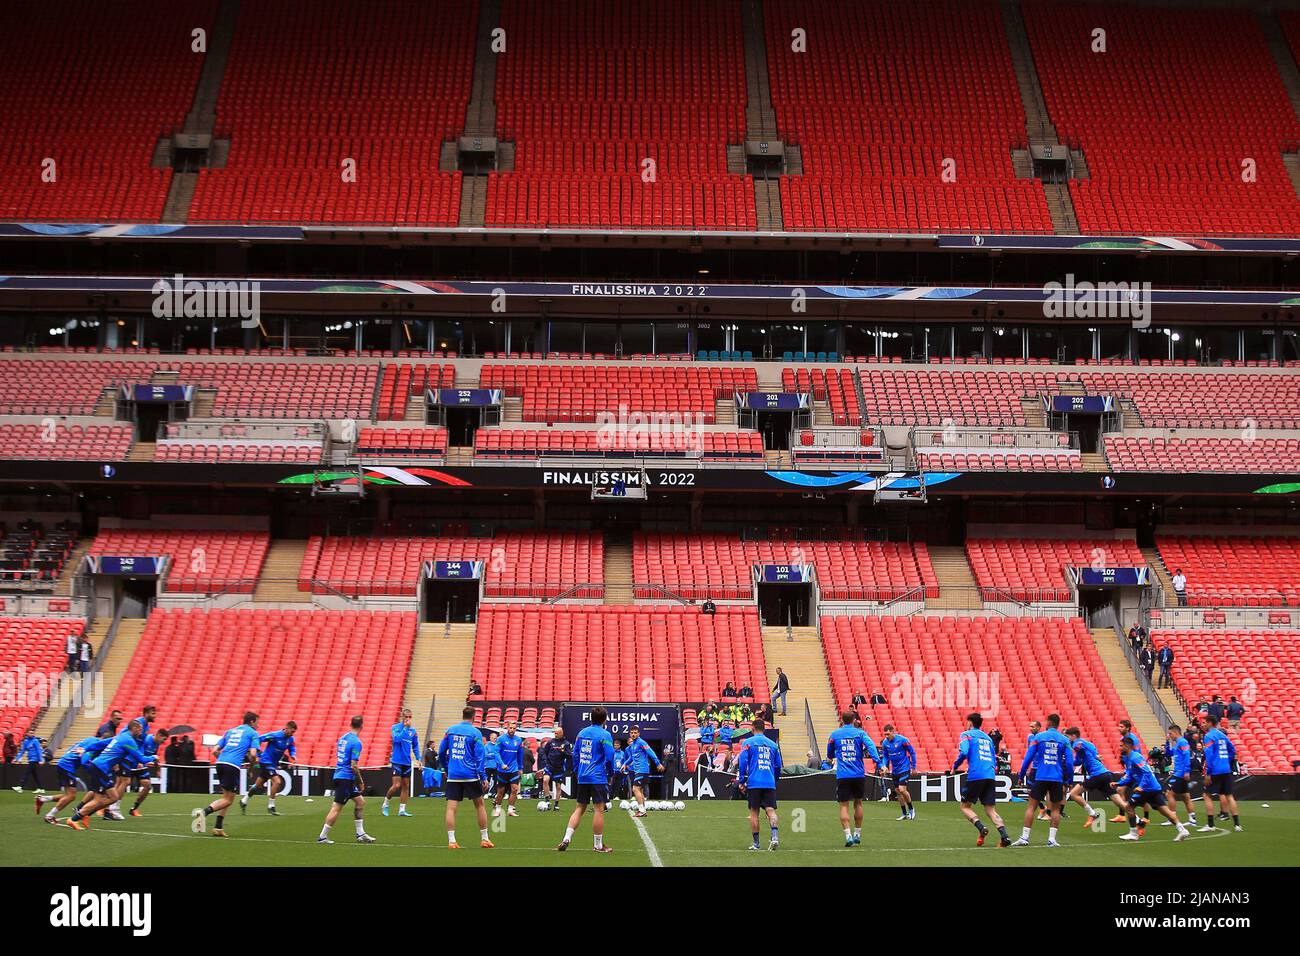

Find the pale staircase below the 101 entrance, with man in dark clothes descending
[[763, 627, 840, 763]]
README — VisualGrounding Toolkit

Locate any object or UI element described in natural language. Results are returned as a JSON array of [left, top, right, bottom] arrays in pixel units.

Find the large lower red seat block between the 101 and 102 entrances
[[822, 617, 1127, 771]]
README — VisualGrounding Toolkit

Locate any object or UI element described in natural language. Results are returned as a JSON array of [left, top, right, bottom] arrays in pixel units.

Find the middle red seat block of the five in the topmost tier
[[486, 0, 757, 229]]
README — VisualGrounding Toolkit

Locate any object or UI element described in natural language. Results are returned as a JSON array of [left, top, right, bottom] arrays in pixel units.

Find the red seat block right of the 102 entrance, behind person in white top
[[1156, 535, 1300, 607]]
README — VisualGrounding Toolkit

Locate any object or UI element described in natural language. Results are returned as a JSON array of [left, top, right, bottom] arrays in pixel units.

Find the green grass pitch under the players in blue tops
[[0, 791, 1300, 866]]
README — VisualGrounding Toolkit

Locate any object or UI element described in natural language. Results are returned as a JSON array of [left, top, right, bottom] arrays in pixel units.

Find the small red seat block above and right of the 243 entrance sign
[[87, 528, 270, 594]]
